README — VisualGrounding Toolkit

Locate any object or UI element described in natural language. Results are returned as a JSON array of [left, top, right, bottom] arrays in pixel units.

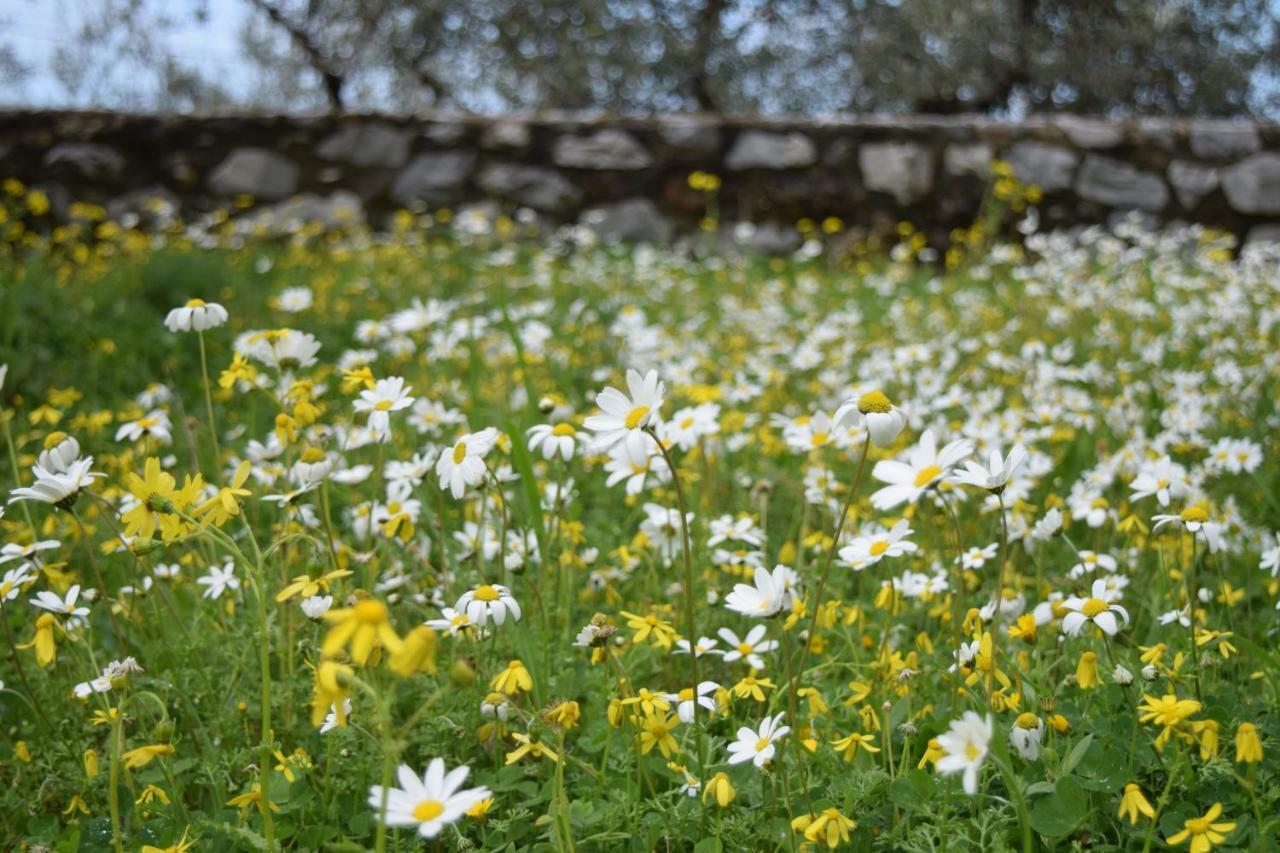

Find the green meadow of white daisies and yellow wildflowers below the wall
[[0, 175, 1280, 853]]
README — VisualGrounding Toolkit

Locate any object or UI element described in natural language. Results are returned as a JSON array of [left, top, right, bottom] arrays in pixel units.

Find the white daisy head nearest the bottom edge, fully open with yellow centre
[[369, 758, 493, 838]]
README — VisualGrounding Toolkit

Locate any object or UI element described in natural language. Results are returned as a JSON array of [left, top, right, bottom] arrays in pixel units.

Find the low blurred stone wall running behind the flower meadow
[[0, 111, 1280, 248]]
